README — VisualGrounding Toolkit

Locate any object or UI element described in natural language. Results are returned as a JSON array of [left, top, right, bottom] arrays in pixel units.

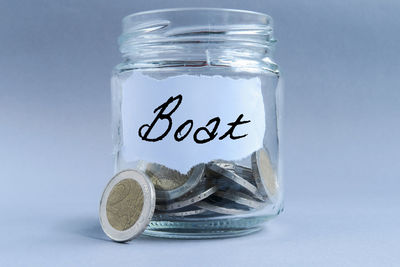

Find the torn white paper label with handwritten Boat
[[121, 72, 265, 173]]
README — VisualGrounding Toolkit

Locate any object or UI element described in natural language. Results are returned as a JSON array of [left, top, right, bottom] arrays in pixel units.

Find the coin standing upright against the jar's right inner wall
[[251, 149, 279, 202]]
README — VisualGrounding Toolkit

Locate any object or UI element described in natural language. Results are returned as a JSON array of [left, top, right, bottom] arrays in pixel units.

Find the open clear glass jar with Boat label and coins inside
[[112, 8, 283, 238]]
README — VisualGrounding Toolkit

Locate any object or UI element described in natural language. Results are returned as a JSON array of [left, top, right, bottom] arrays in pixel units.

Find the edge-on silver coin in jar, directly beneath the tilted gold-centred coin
[[156, 185, 218, 211]]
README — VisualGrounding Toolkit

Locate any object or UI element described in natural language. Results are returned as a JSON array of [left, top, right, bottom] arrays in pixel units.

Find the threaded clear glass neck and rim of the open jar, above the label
[[119, 9, 278, 73]]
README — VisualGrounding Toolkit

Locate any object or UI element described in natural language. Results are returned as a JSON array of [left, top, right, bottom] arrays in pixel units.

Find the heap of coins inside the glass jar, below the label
[[149, 149, 279, 219]]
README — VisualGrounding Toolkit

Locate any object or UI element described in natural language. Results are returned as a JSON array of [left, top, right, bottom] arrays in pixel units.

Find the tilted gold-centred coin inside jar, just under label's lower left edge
[[144, 163, 205, 201]]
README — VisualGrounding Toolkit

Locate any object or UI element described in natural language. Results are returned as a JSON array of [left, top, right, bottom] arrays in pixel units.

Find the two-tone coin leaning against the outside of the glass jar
[[100, 170, 156, 242]]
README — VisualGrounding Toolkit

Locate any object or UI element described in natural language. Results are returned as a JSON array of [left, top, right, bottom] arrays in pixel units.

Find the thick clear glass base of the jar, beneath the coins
[[143, 215, 276, 239]]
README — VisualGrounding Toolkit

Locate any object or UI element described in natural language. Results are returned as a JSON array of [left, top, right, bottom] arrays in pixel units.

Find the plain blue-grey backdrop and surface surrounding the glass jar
[[0, 0, 400, 266]]
